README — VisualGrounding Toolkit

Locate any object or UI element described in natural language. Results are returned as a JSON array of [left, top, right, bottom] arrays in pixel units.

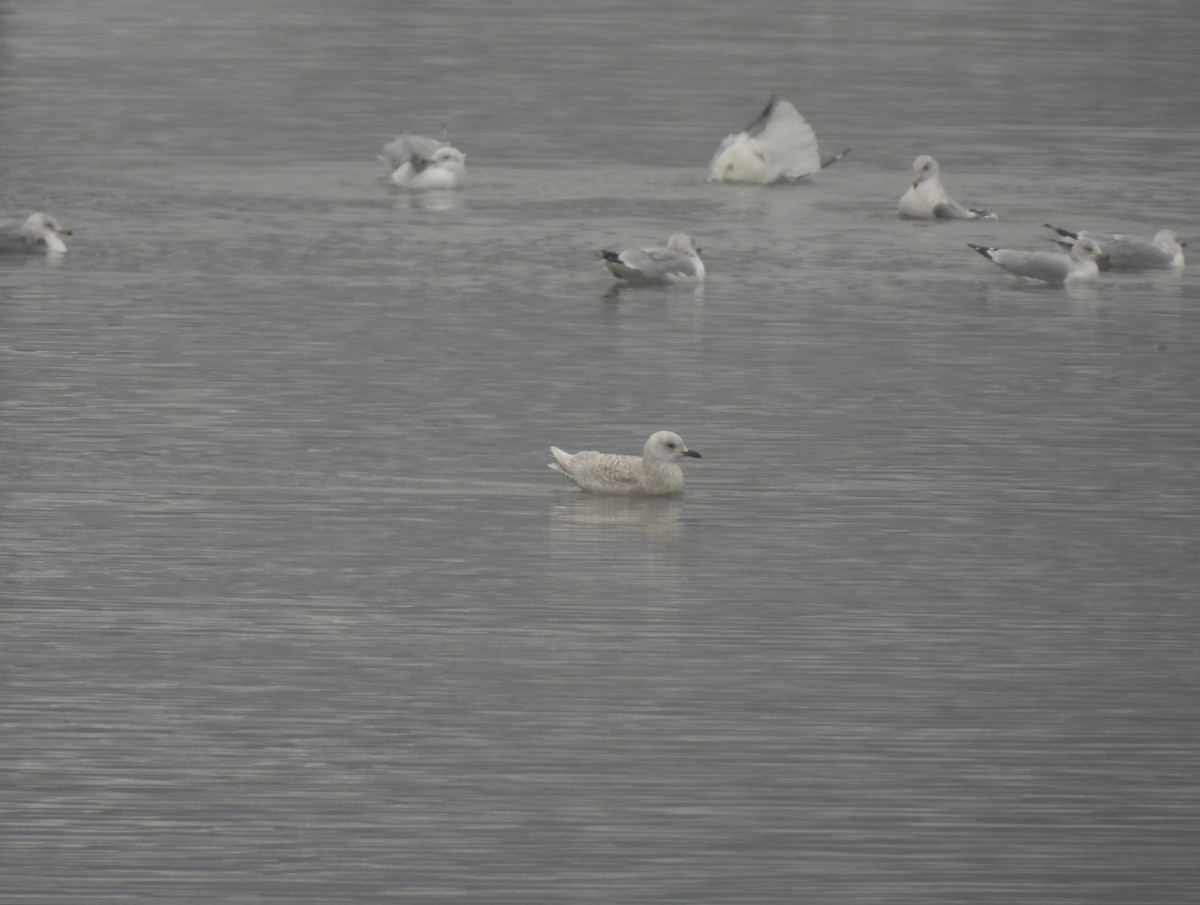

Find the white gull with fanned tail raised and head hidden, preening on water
[[708, 95, 850, 184]]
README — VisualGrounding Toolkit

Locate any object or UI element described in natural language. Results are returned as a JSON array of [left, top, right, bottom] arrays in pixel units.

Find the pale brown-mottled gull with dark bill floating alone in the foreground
[[548, 431, 700, 497]]
